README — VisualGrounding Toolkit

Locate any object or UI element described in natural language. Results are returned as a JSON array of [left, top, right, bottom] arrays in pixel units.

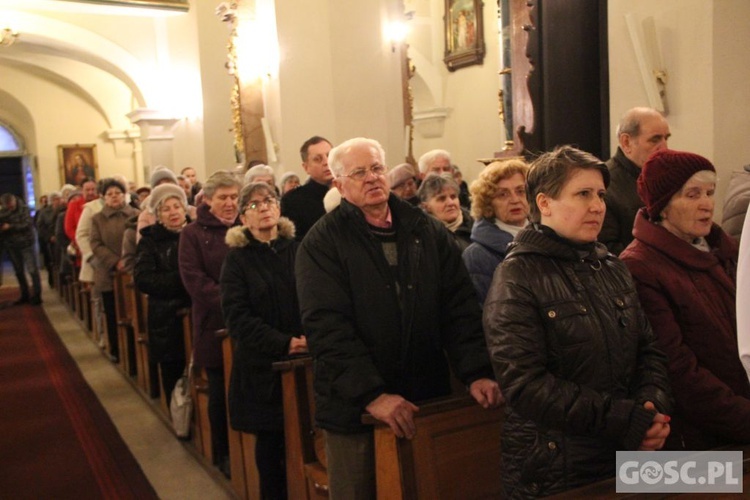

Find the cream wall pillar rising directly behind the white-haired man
[[274, 0, 404, 173]]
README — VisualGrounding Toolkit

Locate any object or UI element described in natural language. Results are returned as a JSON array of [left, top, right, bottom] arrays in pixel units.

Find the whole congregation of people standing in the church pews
[[0, 108, 750, 499]]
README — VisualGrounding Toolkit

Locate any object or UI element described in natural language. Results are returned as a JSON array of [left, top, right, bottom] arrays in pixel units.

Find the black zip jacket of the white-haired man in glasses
[[297, 195, 492, 433]]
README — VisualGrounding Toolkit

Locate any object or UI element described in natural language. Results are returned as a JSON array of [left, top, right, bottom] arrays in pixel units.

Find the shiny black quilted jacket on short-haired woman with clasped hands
[[484, 228, 672, 498]]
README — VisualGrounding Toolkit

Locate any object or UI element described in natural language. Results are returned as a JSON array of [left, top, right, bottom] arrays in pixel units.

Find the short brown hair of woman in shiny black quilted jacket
[[526, 146, 609, 223]]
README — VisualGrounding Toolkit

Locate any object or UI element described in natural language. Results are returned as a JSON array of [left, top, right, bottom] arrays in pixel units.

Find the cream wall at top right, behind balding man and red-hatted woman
[[609, 0, 750, 220]]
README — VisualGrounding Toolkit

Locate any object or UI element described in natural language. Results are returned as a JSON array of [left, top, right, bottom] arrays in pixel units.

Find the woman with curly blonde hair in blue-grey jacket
[[463, 159, 529, 304]]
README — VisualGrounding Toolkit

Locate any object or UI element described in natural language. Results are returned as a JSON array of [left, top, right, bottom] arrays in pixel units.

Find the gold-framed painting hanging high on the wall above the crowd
[[443, 0, 485, 71]]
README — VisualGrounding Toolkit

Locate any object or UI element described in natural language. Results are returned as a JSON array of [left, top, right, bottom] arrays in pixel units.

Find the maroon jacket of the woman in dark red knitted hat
[[620, 209, 750, 450]]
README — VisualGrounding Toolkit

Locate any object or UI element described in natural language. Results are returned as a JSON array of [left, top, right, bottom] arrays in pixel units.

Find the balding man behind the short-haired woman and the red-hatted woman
[[599, 107, 671, 255]]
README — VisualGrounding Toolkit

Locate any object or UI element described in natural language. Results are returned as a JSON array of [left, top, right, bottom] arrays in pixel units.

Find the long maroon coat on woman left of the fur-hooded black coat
[[179, 205, 238, 368]]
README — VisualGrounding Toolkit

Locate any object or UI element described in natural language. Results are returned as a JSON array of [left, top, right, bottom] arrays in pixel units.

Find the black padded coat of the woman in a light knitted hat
[[133, 223, 190, 363]]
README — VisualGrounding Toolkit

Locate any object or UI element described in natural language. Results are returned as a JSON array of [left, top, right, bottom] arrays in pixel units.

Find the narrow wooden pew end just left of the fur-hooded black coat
[[217, 330, 260, 499]]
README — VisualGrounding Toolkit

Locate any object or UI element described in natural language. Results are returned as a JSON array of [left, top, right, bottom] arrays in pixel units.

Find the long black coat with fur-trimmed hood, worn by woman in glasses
[[220, 217, 302, 432]]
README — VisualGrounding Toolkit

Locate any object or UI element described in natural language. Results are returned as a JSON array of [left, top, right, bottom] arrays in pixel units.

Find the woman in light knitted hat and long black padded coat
[[133, 184, 190, 401]]
